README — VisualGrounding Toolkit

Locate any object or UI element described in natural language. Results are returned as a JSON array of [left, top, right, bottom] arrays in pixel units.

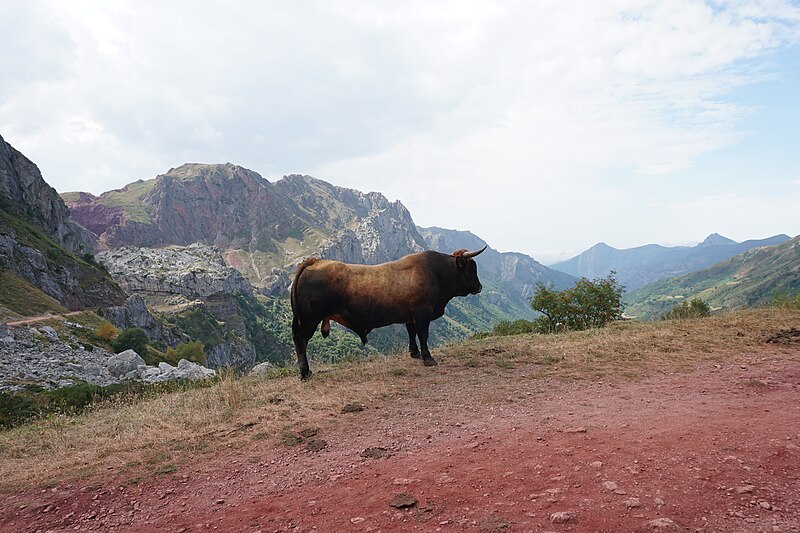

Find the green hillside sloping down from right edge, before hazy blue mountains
[[625, 236, 800, 319]]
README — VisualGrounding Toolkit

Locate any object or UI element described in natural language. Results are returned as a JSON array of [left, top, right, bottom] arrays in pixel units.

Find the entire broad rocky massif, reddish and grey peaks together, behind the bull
[[64, 167, 432, 293]]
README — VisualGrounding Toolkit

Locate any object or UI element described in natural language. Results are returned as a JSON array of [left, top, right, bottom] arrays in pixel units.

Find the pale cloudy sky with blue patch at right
[[0, 0, 800, 264]]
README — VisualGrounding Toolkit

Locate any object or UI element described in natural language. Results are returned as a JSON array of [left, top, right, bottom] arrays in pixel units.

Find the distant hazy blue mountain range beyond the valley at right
[[551, 233, 789, 292]]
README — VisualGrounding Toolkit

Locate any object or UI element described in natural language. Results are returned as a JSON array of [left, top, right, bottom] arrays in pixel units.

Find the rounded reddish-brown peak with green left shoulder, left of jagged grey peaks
[[68, 163, 305, 252]]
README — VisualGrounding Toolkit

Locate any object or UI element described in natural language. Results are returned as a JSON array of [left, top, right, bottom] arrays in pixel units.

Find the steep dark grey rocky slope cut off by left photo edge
[[0, 137, 125, 317]]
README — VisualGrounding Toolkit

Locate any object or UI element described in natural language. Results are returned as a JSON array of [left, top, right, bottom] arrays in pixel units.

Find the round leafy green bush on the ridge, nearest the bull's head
[[531, 272, 625, 333]]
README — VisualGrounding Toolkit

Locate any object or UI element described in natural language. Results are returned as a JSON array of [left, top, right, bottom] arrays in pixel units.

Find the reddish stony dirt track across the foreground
[[0, 346, 800, 532]]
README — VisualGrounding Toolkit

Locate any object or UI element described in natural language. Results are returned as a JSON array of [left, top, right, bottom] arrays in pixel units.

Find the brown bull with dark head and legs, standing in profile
[[291, 246, 486, 380]]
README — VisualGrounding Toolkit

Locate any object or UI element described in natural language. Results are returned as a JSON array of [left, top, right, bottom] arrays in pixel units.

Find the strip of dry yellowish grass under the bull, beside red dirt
[[0, 309, 800, 492]]
